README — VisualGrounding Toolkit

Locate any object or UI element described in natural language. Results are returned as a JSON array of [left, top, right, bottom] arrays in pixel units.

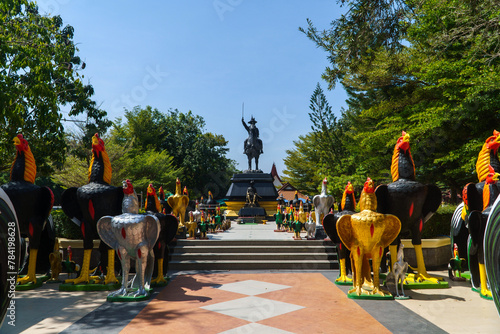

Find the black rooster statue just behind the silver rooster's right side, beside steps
[[146, 184, 179, 285]]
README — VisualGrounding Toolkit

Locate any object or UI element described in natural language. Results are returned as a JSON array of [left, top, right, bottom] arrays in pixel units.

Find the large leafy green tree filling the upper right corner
[[296, 0, 500, 201]]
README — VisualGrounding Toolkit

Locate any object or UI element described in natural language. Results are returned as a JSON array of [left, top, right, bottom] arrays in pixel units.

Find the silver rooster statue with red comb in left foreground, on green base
[[97, 181, 160, 301]]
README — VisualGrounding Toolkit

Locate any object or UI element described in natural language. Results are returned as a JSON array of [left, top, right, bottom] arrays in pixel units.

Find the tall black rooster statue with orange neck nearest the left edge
[[1, 134, 54, 284]]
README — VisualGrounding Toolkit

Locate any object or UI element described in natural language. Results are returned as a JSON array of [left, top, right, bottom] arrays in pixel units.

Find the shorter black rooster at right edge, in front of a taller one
[[465, 166, 500, 299]]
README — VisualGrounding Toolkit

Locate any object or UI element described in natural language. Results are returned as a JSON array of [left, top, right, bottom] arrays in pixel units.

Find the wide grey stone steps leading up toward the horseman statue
[[168, 239, 339, 270]]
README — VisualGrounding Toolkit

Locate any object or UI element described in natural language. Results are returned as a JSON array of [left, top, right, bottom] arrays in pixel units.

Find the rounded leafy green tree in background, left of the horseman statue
[[110, 106, 235, 197]]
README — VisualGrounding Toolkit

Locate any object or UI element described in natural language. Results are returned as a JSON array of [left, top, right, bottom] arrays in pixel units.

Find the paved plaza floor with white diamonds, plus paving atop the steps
[[0, 223, 500, 334]]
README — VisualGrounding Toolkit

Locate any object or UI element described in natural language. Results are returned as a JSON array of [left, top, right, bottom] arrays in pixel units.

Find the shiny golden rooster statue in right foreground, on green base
[[337, 178, 401, 298]]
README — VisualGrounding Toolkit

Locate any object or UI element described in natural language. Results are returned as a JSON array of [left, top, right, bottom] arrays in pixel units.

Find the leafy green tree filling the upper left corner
[[0, 0, 109, 175]]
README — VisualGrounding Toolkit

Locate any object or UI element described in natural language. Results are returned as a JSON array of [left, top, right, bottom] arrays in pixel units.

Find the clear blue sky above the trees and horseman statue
[[38, 0, 346, 175]]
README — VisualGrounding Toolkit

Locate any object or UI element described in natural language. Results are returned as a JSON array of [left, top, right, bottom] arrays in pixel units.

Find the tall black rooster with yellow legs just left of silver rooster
[[61, 133, 123, 284]]
